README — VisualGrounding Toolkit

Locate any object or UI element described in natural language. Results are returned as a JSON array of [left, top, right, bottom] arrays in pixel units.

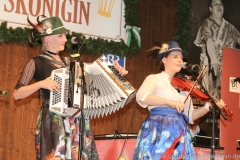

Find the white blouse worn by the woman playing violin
[[136, 71, 194, 124]]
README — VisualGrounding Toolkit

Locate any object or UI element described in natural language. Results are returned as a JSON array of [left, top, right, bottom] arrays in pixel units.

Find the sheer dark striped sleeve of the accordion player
[[15, 59, 35, 89]]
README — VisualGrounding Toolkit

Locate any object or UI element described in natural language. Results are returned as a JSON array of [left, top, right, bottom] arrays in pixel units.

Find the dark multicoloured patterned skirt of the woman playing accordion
[[36, 104, 99, 160]]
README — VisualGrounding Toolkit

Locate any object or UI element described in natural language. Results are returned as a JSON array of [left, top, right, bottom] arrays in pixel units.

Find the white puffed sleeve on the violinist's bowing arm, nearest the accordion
[[136, 75, 157, 108]]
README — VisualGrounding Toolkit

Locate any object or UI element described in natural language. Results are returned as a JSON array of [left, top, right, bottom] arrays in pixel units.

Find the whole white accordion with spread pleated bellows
[[49, 55, 136, 118]]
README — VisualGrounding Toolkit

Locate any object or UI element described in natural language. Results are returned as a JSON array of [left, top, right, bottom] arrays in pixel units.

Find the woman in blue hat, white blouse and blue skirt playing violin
[[133, 41, 225, 160]]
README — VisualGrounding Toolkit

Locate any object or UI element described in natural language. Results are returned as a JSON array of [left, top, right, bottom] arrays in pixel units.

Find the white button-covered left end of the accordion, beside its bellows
[[49, 64, 81, 117]]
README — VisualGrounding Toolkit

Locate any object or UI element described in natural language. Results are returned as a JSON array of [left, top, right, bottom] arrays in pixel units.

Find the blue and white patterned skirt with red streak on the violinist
[[133, 107, 196, 160]]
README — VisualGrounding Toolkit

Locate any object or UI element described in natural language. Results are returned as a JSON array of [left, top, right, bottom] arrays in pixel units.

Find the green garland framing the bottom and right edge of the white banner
[[0, 0, 140, 57]]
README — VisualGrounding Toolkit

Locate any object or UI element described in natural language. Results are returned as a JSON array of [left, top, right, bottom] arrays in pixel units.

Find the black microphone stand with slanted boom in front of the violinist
[[188, 65, 227, 160]]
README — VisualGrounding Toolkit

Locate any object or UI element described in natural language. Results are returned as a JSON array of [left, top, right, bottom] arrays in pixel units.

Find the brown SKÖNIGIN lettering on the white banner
[[4, 0, 91, 25]]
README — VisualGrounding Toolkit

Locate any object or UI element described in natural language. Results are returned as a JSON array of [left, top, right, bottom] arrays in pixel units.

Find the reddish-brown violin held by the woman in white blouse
[[171, 75, 233, 117]]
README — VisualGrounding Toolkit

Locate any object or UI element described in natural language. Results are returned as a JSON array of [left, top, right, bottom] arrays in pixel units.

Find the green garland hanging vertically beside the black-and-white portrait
[[173, 0, 192, 51]]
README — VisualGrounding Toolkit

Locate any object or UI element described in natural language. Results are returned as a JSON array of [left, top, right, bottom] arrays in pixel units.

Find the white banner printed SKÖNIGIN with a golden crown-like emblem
[[0, 0, 125, 41]]
